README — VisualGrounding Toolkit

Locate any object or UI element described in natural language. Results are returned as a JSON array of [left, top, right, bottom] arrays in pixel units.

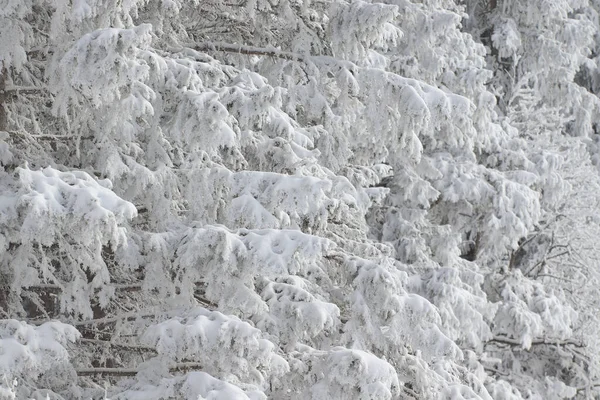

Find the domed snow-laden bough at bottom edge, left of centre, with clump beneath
[[114, 308, 289, 400]]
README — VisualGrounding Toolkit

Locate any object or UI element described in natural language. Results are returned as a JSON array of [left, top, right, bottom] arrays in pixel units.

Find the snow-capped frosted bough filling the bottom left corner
[[0, 319, 80, 399]]
